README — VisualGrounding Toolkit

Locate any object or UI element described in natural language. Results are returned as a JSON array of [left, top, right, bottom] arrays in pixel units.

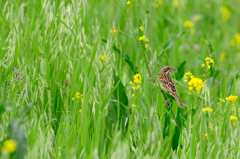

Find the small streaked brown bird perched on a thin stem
[[157, 66, 184, 108]]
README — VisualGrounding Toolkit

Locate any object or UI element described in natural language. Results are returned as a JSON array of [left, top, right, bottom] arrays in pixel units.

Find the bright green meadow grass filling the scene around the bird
[[0, 0, 240, 158]]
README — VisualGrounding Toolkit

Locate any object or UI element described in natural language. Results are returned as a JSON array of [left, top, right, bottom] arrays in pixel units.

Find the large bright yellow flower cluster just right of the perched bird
[[184, 72, 203, 94]]
